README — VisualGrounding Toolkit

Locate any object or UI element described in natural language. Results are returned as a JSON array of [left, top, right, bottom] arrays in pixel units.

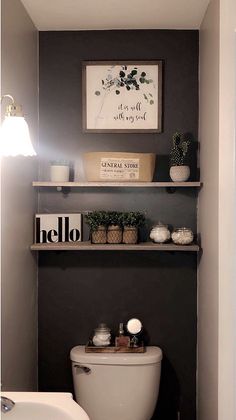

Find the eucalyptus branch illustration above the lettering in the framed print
[[95, 65, 155, 123]]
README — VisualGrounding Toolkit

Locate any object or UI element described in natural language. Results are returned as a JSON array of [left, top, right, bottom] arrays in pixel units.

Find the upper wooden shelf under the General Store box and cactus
[[32, 181, 202, 188]]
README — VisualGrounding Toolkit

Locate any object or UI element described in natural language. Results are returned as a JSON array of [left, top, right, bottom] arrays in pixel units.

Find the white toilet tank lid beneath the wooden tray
[[70, 346, 162, 365]]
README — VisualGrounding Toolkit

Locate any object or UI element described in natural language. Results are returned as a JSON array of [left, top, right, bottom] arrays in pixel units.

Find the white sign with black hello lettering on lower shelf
[[35, 213, 82, 243]]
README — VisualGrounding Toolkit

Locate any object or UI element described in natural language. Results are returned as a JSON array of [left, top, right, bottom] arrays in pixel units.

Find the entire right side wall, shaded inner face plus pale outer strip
[[198, 0, 236, 420]]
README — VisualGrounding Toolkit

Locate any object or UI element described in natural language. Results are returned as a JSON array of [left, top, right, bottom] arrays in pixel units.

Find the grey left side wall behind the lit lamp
[[1, 0, 38, 391]]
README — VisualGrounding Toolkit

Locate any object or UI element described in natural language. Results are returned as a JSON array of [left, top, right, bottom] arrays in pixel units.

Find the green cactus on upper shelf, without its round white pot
[[170, 132, 190, 166]]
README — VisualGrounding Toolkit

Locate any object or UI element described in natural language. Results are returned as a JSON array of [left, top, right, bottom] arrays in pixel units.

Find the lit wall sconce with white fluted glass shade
[[0, 95, 36, 156]]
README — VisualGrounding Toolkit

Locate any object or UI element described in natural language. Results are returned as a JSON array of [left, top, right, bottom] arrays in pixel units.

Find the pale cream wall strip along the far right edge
[[218, 0, 236, 420]]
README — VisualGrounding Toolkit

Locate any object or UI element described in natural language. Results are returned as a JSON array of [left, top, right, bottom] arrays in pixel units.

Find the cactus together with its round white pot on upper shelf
[[170, 132, 190, 182]]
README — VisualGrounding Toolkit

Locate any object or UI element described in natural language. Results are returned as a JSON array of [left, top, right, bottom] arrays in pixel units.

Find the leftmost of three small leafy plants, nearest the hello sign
[[85, 210, 108, 244]]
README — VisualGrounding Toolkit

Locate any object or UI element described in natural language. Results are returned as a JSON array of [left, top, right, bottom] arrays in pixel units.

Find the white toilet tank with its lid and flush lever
[[70, 346, 162, 420]]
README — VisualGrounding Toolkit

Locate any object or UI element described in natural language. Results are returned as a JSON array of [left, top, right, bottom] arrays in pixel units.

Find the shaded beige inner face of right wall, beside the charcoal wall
[[198, 0, 219, 420]]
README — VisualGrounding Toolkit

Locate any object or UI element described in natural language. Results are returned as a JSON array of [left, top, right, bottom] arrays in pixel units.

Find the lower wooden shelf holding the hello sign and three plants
[[30, 242, 200, 252]]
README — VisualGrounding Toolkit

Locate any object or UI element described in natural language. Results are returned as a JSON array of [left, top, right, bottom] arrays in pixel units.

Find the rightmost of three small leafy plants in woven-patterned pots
[[122, 211, 145, 244]]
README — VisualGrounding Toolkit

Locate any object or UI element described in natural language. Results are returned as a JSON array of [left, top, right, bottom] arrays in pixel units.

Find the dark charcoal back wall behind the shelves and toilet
[[39, 30, 198, 420]]
